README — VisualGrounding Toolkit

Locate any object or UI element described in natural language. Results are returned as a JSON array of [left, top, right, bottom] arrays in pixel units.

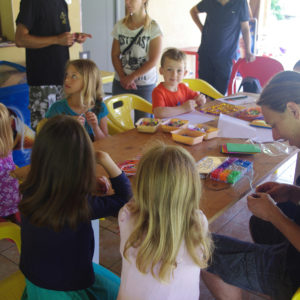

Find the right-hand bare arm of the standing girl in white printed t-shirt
[[123, 36, 162, 85]]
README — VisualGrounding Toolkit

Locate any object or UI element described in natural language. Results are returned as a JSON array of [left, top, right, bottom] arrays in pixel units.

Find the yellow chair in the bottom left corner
[[0, 222, 25, 300]]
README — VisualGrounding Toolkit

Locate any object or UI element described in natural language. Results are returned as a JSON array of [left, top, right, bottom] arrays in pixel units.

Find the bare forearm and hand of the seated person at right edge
[[247, 193, 300, 251]]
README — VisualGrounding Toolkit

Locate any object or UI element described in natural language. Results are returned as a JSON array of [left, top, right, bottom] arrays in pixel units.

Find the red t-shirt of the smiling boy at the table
[[152, 82, 198, 109]]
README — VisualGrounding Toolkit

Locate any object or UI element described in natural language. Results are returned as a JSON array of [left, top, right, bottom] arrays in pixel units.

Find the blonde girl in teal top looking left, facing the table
[[46, 59, 108, 141]]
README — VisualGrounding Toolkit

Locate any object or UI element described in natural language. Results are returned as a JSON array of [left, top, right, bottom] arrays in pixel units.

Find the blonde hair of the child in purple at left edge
[[0, 103, 14, 157]]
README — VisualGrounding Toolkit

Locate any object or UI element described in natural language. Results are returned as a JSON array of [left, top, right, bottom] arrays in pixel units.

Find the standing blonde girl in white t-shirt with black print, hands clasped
[[111, 0, 162, 120]]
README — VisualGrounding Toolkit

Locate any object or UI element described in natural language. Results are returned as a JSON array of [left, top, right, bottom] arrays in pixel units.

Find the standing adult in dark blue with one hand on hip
[[190, 0, 255, 94]]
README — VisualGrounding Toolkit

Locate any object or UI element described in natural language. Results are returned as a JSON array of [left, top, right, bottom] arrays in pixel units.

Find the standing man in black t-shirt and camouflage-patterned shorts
[[15, 0, 91, 129]]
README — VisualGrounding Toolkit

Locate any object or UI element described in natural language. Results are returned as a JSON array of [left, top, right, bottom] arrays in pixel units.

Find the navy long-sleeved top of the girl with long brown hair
[[20, 173, 132, 291]]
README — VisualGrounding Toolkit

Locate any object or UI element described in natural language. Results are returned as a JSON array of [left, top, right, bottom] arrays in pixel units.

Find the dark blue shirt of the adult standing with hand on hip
[[197, 0, 249, 58]]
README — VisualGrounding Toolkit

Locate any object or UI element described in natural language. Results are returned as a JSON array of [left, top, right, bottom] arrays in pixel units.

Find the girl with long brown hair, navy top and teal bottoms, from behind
[[19, 116, 131, 299]]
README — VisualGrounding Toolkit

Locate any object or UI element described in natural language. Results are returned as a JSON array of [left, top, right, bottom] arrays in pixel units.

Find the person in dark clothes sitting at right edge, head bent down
[[202, 71, 300, 300]]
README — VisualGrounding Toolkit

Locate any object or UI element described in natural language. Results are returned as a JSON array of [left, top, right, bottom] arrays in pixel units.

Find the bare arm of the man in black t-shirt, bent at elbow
[[15, 23, 74, 49]]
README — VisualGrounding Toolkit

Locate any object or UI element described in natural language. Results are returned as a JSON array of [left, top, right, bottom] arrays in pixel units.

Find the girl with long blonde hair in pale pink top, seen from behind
[[118, 145, 212, 300]]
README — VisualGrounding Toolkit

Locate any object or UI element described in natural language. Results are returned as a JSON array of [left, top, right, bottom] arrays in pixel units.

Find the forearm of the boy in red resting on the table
[[153, 100, 197, 119]]
